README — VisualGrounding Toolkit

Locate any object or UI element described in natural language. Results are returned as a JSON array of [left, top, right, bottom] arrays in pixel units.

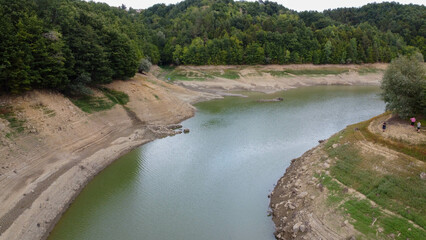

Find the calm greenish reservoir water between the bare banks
[[49, 86, 384, 240]]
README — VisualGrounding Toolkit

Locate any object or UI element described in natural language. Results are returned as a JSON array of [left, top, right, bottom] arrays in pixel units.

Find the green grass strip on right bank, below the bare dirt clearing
[[329, 142, 426, 227]]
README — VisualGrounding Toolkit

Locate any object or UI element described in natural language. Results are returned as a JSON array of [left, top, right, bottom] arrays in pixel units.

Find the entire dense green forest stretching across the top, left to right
[[0, 0, 426, 94]]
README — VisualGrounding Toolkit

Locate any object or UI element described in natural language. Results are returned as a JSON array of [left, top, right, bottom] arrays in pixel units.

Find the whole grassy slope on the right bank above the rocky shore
[[316, 113, 426, 239]]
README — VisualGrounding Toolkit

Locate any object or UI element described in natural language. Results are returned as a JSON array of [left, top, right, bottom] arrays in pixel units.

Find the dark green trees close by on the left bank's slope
[[0, 0, 150, 95]]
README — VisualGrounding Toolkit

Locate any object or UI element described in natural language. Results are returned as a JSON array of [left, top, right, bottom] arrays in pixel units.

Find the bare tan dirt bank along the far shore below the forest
[[156, 64, 387, 94]]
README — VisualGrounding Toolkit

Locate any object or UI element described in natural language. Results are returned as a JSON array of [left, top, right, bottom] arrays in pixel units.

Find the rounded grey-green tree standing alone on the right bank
[[381, 55, 426, 118]]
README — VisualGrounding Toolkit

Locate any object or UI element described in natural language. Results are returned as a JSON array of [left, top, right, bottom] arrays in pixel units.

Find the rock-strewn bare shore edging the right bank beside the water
[[270, 142, 358, 239]]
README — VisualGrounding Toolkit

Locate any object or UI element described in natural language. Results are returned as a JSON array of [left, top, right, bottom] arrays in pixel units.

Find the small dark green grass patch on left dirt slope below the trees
[[71, 96, 115, 113]]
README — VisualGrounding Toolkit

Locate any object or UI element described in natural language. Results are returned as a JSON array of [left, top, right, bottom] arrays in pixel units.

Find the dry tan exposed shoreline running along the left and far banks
[[0, 65, 383, 240]]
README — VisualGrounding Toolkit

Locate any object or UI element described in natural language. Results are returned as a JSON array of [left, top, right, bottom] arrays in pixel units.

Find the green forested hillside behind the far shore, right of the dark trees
[[142, 0, 424, 65]]
